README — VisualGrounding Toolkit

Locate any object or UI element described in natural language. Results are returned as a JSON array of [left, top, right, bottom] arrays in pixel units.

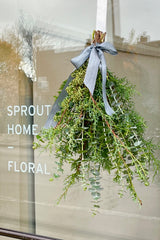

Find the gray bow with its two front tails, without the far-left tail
[[71, 42, 117, 116]]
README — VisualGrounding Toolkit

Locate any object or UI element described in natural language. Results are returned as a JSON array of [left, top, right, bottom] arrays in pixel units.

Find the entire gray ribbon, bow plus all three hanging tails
[[44, 42, 117, 129]]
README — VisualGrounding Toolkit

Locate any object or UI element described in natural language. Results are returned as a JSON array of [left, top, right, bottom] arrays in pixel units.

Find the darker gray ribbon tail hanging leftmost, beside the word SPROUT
[[44, 75, 73, 129]]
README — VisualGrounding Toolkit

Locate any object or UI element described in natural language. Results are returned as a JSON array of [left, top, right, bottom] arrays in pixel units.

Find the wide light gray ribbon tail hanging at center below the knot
[[84, 48, 100, 95]]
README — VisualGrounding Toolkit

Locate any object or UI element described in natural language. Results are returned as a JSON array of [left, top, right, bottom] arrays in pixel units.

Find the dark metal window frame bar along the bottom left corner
[[0, 228, 62, 240]]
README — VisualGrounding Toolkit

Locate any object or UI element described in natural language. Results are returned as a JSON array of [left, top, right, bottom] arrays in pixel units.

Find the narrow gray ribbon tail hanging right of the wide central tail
[[100, 52, 115, 116]]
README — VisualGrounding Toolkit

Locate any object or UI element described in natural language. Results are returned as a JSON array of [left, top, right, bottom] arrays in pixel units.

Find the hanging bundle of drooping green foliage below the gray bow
[[34, 63, 160, 214]]
